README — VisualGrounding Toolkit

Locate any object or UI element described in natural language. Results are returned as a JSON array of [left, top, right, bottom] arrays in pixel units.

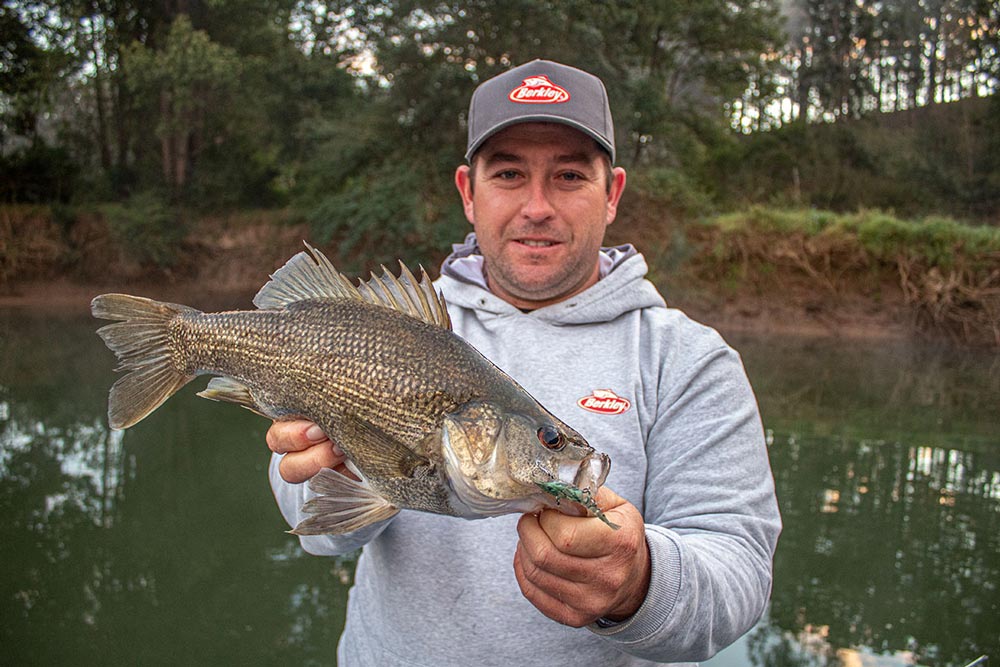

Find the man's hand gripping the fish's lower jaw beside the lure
[[514, 487, 650, 628]]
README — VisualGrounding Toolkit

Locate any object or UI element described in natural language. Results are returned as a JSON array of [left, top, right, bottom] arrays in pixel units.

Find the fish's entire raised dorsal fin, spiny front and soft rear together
[[253, 243, 451, 330]]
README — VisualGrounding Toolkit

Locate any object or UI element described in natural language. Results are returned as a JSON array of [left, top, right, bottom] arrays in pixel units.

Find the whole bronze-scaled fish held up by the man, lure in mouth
[[91, 243, 611, 535]]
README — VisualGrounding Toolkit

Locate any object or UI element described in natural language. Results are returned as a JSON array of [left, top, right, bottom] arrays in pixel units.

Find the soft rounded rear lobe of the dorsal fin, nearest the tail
[[253, 243, 362, 310]]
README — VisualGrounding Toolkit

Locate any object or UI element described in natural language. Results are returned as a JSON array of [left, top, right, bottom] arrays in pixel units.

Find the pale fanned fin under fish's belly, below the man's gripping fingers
[[288, 468, 399, 535]]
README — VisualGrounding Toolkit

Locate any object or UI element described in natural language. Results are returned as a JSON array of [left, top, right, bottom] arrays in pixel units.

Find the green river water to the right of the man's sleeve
[[720, 341, 1000, 666]]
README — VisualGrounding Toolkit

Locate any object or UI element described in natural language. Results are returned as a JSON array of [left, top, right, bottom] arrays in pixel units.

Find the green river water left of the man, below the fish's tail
[[0, 313, 349, 664]]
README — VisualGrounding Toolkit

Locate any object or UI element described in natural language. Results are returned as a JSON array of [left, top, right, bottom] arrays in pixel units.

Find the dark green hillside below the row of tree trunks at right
[[705, 100, 1000, 220]]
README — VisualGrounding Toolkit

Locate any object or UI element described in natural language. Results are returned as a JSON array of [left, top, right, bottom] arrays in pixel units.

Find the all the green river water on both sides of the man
[[0, 310, 1000, 667]]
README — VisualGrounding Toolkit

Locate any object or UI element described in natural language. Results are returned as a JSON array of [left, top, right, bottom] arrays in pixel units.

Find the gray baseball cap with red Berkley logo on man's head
[[465, 60, 615, 163]]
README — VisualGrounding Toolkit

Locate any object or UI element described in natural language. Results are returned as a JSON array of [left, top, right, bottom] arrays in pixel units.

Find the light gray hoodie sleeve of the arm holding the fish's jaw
[[590, 336, 781, 662]]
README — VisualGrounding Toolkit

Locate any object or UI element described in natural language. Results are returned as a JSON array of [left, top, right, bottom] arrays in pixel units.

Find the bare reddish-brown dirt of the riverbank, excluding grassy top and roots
[[0, 211, 968, 348]]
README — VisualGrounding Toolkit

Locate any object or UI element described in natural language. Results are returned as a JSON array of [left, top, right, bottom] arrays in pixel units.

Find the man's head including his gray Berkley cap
[[455, 60, 625, 309]]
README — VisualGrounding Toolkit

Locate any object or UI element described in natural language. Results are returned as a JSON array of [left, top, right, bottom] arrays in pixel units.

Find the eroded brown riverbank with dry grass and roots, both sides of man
[[0, 206, 1000, 346]]
